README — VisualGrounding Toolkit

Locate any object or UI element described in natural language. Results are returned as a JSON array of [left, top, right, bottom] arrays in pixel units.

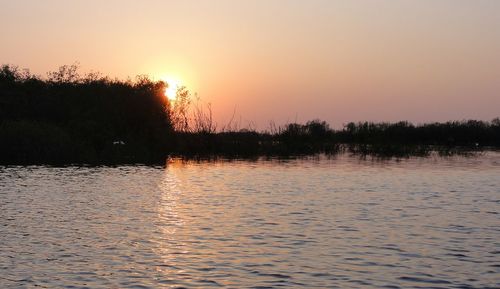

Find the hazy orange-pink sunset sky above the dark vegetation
[[0, 0, 500, 129]]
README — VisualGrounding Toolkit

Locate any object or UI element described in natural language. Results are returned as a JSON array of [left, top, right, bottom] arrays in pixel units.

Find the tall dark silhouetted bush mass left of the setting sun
[[0, 65, 173, 163]]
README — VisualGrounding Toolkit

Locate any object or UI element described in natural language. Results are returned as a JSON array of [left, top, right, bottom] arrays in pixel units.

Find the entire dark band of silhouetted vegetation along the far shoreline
[[0, 65, 500, 164]]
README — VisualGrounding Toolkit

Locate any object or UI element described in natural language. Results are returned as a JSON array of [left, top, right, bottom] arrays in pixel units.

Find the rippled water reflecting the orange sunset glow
[[0, 153, 500, 288]]
